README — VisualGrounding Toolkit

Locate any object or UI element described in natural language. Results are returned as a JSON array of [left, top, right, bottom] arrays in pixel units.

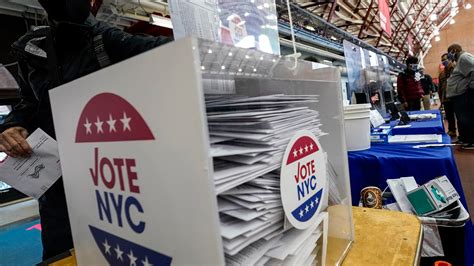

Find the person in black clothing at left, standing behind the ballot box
[[0, 0, 170, 260]]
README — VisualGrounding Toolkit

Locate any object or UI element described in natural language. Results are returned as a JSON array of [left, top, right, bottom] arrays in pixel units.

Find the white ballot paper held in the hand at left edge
[[0, 129, 62, 199]]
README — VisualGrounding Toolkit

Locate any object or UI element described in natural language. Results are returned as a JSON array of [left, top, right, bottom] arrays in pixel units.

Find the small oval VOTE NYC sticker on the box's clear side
[[280, 130, 326, 229]]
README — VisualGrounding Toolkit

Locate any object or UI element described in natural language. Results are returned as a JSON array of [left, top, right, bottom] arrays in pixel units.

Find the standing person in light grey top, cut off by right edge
[[446, 44, 474, 149]]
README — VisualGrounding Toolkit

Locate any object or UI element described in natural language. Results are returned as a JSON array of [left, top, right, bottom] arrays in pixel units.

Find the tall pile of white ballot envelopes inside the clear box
[[206, 94, 323, 265]]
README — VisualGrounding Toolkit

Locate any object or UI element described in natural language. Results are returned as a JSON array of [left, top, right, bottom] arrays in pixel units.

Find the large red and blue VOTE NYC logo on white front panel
[[76, 93, 172, 266]]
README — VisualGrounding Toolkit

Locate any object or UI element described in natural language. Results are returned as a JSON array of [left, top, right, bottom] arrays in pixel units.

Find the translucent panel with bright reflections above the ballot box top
[[168, 0, 280, 55]]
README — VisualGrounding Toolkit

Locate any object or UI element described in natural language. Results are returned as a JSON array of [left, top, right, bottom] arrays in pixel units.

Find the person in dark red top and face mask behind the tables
[[397, 56, 423, 111]]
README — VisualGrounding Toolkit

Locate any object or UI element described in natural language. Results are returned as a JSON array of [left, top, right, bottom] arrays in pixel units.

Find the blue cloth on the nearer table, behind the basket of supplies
[[348, 134, 474, 265]]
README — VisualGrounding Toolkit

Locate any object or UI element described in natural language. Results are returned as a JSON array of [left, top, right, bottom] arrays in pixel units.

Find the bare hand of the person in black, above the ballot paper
[[0, 127, 31, 157]]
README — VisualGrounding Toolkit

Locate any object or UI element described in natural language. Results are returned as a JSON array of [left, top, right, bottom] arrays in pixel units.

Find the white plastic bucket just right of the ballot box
[[344, 114, 370, 151]]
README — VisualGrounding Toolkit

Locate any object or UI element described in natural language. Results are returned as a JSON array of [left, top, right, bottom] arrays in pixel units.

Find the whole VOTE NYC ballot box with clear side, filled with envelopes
[[50, 38, 354, 265]]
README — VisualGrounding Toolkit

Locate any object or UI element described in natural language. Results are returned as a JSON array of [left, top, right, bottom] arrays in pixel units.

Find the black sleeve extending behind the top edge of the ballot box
[[102, 27, 172, 63]]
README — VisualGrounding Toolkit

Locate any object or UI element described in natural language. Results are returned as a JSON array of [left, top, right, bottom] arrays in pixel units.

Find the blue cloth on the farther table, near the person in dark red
[[384, 110, 445, 135]]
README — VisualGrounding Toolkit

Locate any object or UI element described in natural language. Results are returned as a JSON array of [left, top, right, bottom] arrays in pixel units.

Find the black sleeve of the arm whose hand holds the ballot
[[0, 62, 38, 133]]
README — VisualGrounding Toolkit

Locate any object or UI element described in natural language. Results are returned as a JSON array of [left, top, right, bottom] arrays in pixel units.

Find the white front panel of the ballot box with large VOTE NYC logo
[[50, 39, 224, 265]]
